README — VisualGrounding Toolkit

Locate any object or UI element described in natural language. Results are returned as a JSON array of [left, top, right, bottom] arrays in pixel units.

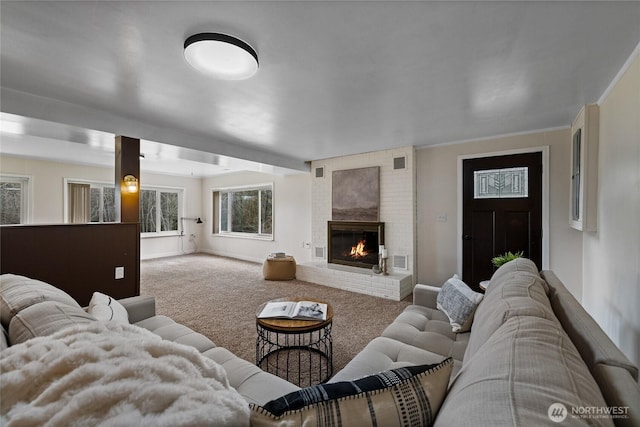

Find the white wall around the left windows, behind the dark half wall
[[0, 155, 204, 259]]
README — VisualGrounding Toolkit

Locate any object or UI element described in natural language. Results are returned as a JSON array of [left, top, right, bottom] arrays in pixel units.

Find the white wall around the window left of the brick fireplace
[[200, 172, 311, 262]]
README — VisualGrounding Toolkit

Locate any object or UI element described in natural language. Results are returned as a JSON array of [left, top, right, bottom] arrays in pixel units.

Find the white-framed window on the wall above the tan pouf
[[213, 184, 273, 237]]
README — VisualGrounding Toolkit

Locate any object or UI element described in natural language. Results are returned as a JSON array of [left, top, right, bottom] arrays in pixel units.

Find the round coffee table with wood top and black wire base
[[256, 298, 333, 387]]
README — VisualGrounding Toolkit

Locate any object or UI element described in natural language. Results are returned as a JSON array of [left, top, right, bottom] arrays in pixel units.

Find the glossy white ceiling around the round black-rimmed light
[[0, 1, 640, 175]]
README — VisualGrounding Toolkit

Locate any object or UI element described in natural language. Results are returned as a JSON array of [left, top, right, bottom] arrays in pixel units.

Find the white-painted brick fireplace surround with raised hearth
[[296, 146, 417, 300]]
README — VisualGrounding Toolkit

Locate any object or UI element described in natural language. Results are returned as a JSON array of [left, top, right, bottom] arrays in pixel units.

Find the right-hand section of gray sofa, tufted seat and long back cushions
[[331, 259, 640, 427]]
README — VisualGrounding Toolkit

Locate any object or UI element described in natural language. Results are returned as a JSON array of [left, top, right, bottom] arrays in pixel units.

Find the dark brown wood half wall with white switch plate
[[0, 223, 140, 306]]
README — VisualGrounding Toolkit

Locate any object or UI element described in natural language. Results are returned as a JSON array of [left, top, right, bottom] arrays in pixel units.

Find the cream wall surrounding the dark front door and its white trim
[[416, 129, 582, 300]]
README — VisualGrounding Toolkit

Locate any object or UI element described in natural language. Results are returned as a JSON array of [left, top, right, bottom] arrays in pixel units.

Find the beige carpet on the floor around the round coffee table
[[140, 254, 411, 373]]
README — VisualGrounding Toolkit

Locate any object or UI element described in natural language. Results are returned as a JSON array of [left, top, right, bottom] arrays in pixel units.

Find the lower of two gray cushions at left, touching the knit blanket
[[9, 301, 96, 345]]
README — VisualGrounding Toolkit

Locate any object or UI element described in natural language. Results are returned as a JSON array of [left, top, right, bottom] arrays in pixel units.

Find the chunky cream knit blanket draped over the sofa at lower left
[[0, 322, 249, 427]]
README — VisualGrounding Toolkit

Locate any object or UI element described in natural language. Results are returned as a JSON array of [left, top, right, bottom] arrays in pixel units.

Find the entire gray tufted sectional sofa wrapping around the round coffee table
[[0, 259, 640, 427]]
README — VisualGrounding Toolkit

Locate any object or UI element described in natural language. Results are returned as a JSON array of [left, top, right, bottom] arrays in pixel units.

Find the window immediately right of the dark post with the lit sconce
[[140, 188, 183, 234]]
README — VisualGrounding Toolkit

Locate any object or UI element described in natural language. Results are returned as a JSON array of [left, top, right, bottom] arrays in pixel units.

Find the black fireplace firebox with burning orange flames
[[327, 221, 384, 268]]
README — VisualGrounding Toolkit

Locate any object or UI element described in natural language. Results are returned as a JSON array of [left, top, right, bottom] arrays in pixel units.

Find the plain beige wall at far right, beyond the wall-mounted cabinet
[[582, 52, 640, 365]]
